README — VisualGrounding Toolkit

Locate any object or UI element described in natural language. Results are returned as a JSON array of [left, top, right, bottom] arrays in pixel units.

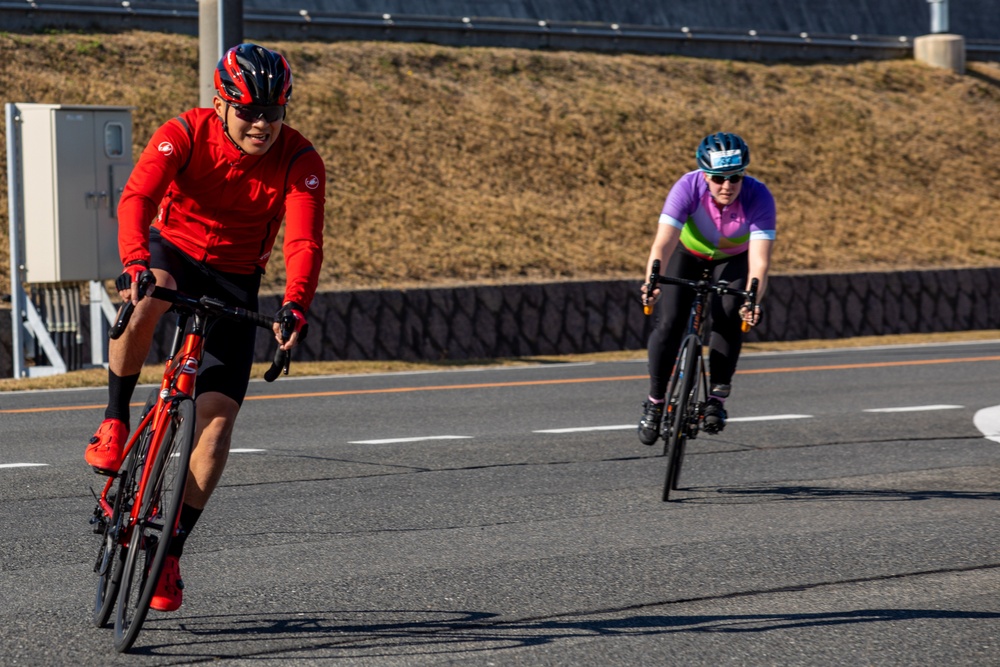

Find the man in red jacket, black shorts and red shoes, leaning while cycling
[[84, 44, 326, 611]]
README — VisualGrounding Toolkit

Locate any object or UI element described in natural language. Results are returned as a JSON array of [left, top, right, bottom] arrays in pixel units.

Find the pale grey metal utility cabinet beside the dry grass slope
[[17, 104, 132, 283]]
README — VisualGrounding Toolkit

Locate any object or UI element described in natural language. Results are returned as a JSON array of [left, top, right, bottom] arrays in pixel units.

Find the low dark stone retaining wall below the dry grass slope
[[0, 267, 1000, 377]]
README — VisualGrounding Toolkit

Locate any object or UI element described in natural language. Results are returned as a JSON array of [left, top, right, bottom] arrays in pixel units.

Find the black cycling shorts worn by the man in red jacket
[[149, 227, 261, 405]]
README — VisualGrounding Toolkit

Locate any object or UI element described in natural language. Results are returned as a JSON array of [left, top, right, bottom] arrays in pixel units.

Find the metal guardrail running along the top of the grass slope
[[0, 0, 1000, 60]]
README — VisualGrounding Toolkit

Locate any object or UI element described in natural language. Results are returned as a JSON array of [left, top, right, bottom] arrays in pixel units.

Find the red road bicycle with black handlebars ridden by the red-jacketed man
[[91, 283, 294, 652]]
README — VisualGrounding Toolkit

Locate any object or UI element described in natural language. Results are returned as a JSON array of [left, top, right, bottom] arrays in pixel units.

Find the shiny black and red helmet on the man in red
[[215, 43, 292, 106]]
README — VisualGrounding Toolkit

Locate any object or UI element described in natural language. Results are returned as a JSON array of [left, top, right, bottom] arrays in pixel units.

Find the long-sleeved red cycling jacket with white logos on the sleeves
[[118, 109, 326, 309]]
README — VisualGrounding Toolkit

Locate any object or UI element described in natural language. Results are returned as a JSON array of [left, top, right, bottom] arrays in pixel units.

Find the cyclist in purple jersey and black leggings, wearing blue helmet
[[639, 132, 775, 445]]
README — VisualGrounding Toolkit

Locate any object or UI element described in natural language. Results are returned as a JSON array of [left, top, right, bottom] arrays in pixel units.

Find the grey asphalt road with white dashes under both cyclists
[[0, 344, 1000, 667]]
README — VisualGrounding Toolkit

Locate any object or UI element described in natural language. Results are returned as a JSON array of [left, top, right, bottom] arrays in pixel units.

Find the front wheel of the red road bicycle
[[115, 398, 195, 653]]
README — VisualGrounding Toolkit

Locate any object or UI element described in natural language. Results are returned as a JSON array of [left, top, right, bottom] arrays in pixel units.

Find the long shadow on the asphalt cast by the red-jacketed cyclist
[[133, 609, 1000, 659]]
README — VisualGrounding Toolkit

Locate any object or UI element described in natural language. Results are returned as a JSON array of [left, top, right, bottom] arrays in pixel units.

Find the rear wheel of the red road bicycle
[[93, 390, 158, 628]]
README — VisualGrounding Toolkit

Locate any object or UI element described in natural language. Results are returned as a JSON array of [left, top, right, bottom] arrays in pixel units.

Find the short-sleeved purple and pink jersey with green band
[[660, 170, 776, 259]]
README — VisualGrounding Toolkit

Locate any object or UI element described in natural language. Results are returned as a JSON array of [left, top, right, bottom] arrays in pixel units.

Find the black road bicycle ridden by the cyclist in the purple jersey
[[646, 259, 758, 501]]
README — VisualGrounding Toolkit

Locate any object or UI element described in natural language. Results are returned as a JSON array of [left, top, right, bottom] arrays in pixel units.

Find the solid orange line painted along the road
[[0, 356, 1000, 414]]
